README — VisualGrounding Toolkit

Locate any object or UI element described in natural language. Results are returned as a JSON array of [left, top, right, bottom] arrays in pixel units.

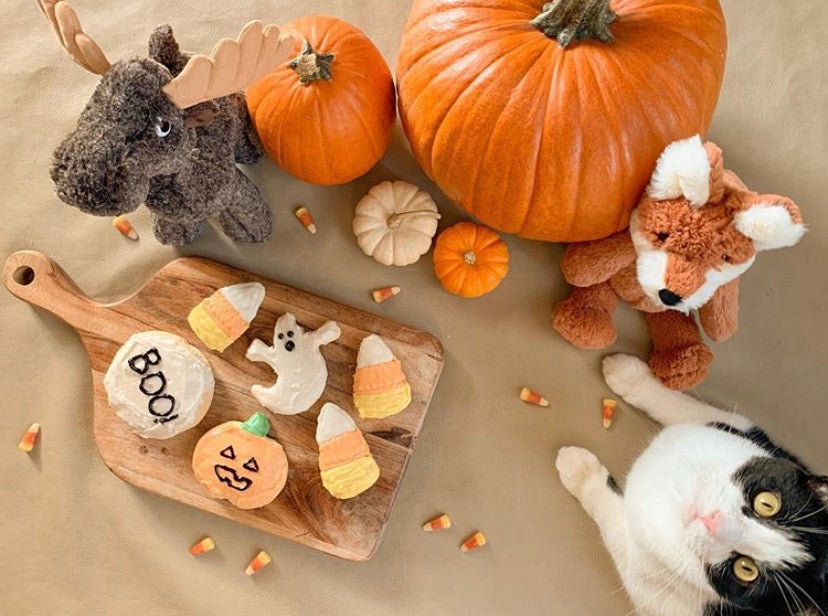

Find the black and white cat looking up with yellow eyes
[[557, 355, 828, 616]]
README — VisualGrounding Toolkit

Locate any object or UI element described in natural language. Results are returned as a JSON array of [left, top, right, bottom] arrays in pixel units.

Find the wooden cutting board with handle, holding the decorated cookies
[[3, 251, 443, 560]]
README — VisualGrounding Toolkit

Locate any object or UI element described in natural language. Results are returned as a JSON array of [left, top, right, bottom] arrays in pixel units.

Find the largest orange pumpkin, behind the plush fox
[[397, 0, 726, 241]]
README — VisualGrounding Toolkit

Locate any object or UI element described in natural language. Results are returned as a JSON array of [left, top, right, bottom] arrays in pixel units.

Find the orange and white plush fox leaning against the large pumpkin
[[553, 136, 805, 390]]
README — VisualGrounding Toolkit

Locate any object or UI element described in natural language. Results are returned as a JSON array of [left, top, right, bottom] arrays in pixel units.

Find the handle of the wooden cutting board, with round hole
[[3, 250, 104, 330]]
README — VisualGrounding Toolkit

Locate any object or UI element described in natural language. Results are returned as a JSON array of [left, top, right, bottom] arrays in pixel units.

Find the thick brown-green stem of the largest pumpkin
[[531, 0, 618, 47]]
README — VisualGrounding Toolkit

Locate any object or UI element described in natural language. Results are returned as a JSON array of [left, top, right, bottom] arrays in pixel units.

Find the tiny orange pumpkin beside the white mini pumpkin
[[434, 222, 509, 297]]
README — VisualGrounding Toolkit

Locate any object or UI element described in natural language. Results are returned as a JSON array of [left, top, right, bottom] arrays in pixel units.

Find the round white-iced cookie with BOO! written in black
[[104, 331, 214, 439]]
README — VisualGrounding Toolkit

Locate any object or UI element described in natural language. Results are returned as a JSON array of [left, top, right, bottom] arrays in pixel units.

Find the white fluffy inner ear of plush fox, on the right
[[733, 195, 806, 250]]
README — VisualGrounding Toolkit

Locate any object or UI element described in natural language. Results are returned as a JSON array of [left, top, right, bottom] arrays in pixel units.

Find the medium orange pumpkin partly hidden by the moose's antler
[[246, 15, 396, 185]]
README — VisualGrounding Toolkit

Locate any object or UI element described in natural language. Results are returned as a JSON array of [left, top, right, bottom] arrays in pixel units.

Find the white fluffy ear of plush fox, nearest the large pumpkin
[[647, 135, 710, 207]]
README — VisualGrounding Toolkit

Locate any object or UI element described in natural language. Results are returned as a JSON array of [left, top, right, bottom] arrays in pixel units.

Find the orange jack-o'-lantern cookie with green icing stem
[[193, 413, 288, 509]]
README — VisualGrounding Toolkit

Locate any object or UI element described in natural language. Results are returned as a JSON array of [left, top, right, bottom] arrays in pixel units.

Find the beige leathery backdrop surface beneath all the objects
[[0, 0, 828, 615]]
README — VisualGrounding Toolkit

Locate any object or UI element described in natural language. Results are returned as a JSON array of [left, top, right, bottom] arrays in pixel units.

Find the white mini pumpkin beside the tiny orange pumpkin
[[354, 181, 440, 265]]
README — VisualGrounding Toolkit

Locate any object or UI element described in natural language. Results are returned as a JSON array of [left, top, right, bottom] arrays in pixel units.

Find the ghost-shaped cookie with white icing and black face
[[247, 312, 340, 415]]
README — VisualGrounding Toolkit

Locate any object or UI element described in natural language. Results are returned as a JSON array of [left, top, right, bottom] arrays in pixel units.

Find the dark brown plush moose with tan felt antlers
[[38, 0, 293, 245]]
